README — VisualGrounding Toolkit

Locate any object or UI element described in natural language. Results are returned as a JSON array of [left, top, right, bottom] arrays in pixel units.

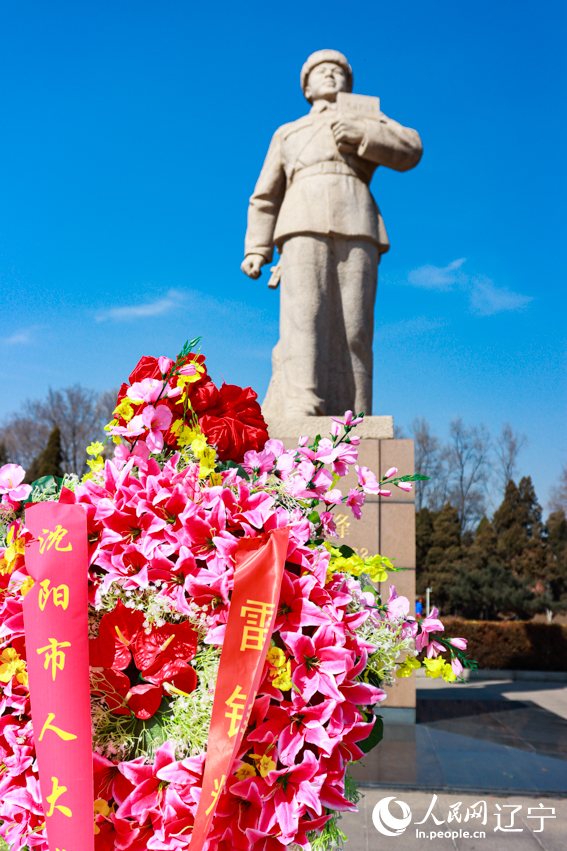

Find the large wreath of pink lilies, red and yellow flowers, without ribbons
[[0, 341, 474, 851]]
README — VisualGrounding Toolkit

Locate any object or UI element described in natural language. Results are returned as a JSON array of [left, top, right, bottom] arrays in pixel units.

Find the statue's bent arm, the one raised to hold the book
[[357, 115, 423, 171]]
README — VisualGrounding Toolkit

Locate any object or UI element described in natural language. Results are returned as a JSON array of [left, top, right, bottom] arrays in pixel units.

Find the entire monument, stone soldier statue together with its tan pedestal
[[242, 50, 422, 724]]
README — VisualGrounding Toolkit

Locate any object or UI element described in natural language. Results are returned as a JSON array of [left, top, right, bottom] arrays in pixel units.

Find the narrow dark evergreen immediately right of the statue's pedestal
[[422, 503, 462, 613]]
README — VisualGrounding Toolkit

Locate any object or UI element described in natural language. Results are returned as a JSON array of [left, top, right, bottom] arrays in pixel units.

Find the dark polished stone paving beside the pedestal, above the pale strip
[[353, 679, 567, 796]]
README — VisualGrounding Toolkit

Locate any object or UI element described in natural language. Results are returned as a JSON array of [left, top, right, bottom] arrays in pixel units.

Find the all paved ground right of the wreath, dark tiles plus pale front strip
[[340, 679, 567, 851]]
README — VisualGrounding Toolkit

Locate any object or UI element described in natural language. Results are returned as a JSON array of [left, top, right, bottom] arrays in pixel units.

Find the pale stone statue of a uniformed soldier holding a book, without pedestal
[[241, 50, 422, 422]]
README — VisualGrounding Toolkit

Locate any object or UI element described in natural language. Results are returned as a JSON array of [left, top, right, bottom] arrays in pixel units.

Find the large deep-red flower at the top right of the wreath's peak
[[199, 384, 268, 462]]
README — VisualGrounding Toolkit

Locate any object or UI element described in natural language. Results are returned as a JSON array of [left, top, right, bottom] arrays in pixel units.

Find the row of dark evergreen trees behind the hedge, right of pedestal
[[416, 477, 567, 618]]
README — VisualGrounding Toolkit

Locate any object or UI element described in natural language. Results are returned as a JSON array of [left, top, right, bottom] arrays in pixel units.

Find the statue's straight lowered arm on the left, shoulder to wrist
[[244, 130, 286, 263]]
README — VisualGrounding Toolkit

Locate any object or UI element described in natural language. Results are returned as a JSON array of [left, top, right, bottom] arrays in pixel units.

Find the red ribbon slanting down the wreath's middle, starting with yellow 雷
[[190, 528, 289, 851]]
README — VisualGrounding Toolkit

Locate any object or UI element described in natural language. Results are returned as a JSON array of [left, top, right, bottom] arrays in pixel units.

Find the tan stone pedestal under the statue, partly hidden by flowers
[[268, 417, 416, 728]]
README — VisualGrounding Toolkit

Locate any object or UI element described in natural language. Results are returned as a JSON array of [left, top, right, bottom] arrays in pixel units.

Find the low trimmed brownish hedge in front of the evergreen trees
[[442, 618, 567, 671]]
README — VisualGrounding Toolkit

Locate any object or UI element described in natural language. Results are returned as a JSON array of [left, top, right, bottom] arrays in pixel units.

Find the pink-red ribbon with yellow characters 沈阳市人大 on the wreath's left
[[24, 502, 94, 851]]
